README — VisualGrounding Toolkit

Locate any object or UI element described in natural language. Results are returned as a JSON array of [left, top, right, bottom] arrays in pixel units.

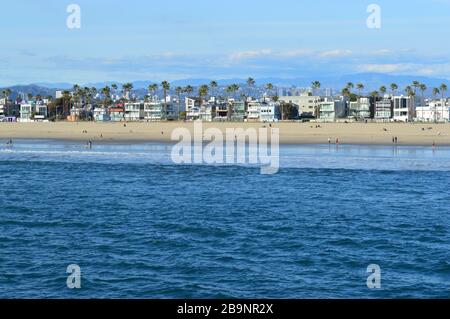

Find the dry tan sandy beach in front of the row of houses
[[0, 122, 450, 146]]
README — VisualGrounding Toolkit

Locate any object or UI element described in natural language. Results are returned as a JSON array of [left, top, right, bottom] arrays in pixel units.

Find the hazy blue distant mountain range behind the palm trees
[[0, 73, 448, 98]]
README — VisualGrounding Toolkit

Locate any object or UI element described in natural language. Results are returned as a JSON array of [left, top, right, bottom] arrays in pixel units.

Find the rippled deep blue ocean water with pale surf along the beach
[[0, 140, 450, 298]]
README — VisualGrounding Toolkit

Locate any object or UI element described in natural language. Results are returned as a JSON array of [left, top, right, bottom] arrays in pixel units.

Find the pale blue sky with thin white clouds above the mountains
[[0, 0, 450, 85]]
